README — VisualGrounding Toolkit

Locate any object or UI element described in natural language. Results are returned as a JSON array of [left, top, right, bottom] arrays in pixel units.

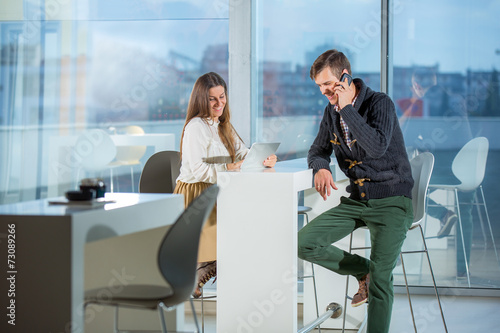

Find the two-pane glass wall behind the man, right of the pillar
[[252, 0, 500, 288]]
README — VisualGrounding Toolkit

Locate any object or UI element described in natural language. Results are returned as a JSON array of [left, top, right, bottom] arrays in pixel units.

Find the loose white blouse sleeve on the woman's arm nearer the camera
[[182, 122, 226, 184]]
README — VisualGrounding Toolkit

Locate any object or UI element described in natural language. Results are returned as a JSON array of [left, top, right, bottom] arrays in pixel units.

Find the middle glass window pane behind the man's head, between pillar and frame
[[253, 0, 381, 159]]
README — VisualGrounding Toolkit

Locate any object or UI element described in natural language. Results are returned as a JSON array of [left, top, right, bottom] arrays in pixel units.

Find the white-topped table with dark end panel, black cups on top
[[0, 193, 184, 333]]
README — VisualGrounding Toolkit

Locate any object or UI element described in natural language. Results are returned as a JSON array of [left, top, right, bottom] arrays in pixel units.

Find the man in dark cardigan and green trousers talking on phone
[[298, 50, 413, 333]]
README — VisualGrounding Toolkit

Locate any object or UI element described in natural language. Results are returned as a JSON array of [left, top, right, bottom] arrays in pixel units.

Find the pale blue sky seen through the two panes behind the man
[[259, 0, 500, 72]]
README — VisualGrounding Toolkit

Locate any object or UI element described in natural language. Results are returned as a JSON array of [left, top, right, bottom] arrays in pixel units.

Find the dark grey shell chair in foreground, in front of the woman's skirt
[[85, 185, 219, 333]]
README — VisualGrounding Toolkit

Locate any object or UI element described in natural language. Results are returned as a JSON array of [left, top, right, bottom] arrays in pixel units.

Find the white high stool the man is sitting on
[[342, 153, 448, 332]]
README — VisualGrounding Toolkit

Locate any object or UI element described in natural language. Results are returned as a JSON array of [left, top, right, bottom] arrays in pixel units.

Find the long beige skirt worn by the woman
[[174, 181, 217, 262]]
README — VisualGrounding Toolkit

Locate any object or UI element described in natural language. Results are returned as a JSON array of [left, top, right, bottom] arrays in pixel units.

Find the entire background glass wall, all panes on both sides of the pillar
[[0, 0, 500, 288]]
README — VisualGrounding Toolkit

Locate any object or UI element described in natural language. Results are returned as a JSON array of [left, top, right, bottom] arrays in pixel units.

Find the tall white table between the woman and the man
[[217, 163, 312, 333]]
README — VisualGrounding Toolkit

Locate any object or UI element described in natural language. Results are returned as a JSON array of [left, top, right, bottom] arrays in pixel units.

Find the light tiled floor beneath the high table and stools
[[186, 295, 500, 333]]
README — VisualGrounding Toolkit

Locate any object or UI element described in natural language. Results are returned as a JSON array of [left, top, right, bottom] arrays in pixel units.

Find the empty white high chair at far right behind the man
[[427, 137, 499, 287]]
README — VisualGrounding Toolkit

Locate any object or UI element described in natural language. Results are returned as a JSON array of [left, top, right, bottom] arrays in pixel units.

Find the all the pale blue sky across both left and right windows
[[23, 0, 500, 73]]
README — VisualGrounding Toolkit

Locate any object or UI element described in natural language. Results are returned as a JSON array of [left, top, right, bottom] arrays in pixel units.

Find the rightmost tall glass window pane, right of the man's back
[[391, 0, 500, 288]]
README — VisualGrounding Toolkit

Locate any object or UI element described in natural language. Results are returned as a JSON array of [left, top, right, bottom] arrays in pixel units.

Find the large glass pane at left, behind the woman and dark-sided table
[[0, 0, 229, 203]]
